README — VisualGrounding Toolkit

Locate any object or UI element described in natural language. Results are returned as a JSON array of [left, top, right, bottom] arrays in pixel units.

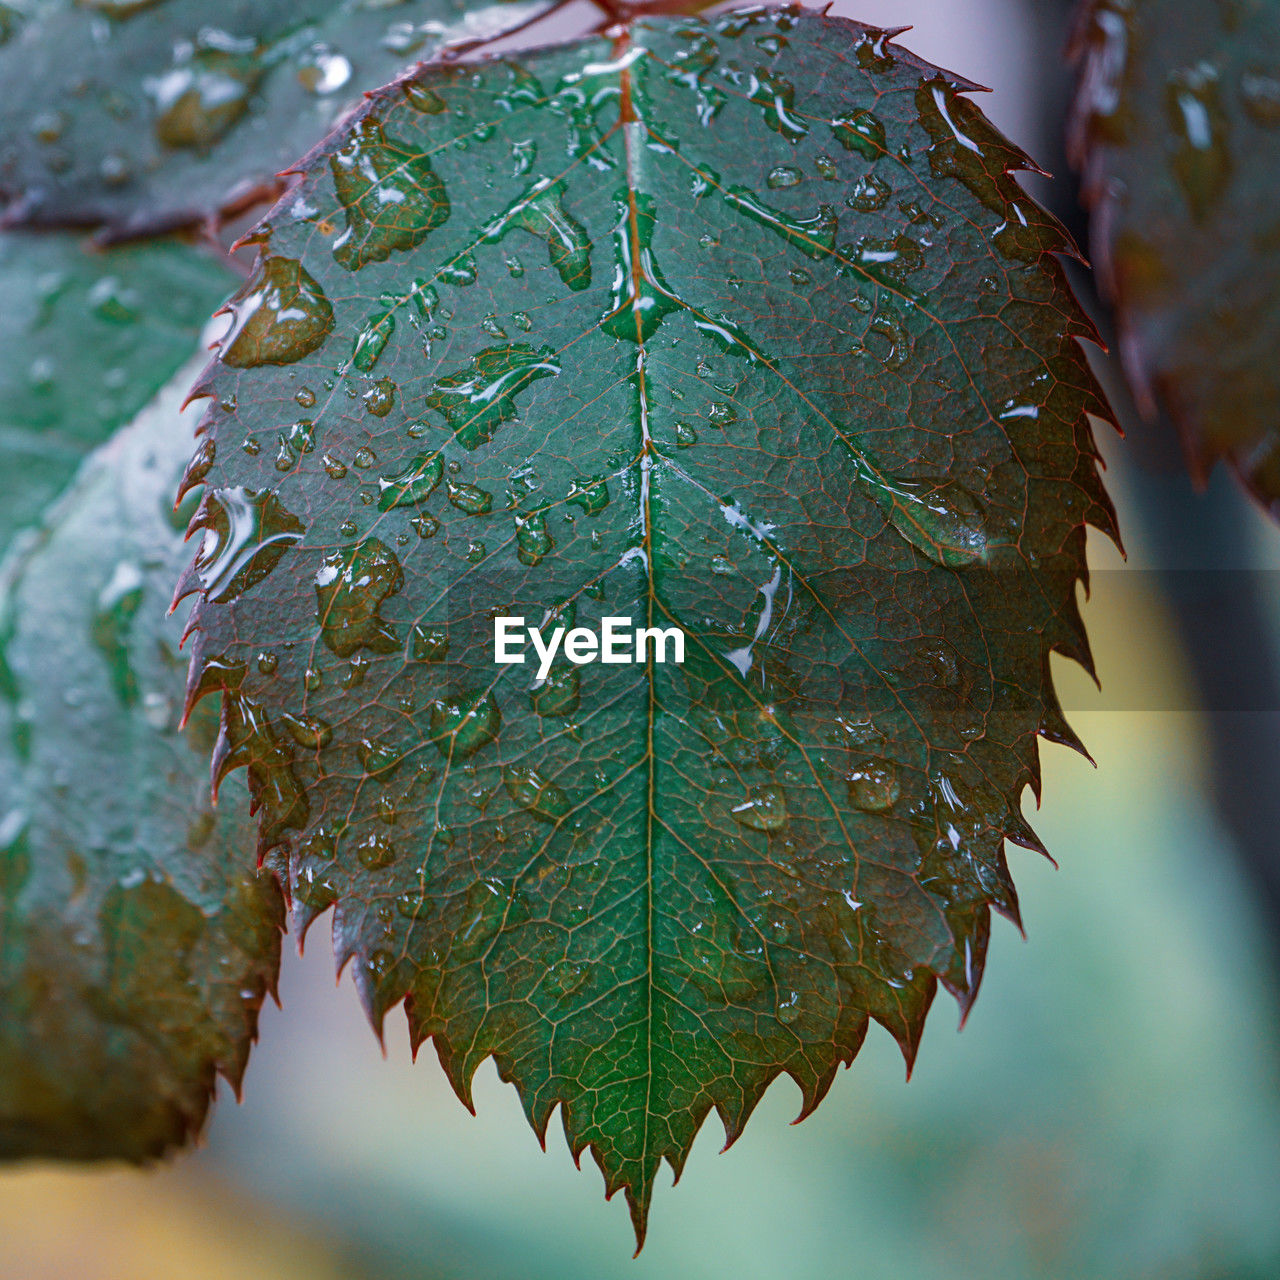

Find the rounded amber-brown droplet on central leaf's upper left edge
[[221, 257, 333, 369]]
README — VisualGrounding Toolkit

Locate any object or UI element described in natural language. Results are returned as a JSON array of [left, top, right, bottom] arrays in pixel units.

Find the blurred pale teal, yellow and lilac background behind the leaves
[[0, 0, 1280, 1280]]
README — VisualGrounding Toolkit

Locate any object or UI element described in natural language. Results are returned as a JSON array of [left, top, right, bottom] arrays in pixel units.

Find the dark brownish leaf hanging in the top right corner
[[1071, 0, 1280, 511]]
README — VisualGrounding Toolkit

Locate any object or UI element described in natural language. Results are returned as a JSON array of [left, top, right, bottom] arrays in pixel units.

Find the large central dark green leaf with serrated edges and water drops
[[179, 10, 1112, 1233]]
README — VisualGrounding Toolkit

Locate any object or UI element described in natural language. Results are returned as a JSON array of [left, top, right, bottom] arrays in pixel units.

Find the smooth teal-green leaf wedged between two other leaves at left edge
[[0, 234, 234, 550]]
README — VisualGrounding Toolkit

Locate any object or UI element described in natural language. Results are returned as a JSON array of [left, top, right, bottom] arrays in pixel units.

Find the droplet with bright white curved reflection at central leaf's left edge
[[192, 488, 306, 603]]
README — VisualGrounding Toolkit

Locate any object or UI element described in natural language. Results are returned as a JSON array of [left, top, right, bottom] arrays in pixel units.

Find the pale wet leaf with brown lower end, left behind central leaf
[[0, 360, 283, 1160]]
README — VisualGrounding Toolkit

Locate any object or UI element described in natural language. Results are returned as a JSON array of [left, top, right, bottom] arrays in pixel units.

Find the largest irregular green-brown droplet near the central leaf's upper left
[[329, 116, 449, 271]]
